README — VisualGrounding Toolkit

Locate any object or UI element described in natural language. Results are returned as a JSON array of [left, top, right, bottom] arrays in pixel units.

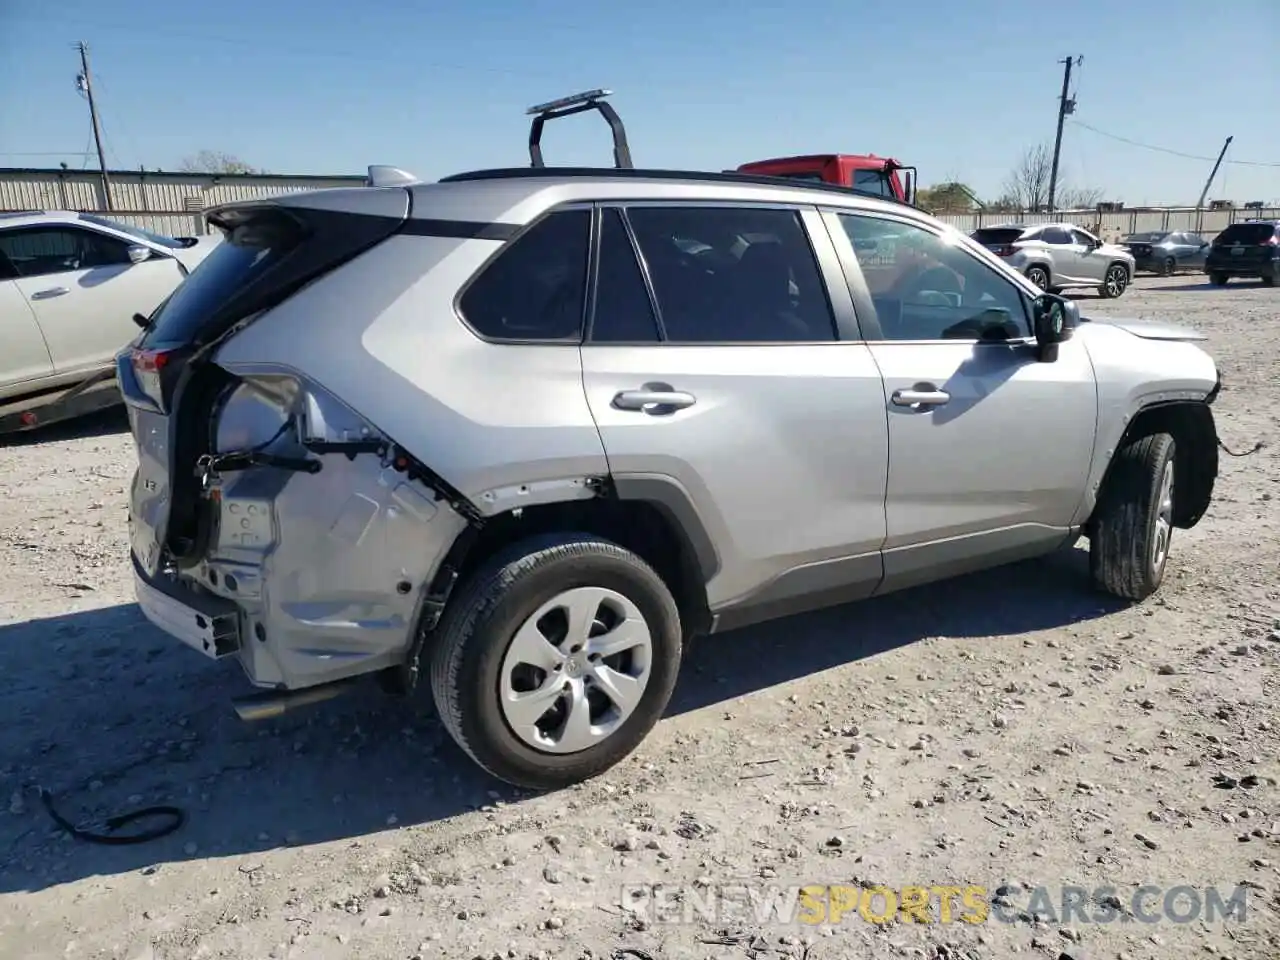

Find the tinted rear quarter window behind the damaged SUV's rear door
[[458, 210, 591, 343]]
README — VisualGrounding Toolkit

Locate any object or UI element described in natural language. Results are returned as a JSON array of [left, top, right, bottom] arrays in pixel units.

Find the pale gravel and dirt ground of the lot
[[0, 276, 1280, 960]]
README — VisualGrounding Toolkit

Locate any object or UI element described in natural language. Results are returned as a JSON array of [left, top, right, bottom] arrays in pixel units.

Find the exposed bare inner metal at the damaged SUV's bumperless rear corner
[[192, 364, 466, 689]]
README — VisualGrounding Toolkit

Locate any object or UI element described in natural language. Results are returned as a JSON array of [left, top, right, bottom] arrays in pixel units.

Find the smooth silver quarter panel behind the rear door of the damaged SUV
[[209, 236, 608, 515]]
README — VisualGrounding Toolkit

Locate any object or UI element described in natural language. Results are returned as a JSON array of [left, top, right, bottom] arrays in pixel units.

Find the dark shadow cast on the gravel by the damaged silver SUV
[[0, 550, 1120, 893]]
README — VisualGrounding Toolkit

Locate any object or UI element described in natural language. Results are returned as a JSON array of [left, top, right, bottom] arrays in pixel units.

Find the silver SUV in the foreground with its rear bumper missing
[[118, 96, 1219, 787]]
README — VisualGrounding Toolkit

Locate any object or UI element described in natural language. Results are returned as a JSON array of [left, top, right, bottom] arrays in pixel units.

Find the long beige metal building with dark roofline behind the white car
[[0, 166, 365, 237]]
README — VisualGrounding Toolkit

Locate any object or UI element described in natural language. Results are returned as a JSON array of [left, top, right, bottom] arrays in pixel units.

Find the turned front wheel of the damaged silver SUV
[[1089, 434, 1176, 600]]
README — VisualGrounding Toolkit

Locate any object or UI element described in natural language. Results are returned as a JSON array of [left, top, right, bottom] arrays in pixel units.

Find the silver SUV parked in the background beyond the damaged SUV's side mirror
[[972, 223, 1135, 297]]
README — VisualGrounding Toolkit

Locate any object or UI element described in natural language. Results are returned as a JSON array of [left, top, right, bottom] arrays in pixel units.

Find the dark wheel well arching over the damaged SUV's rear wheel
[[433, 497, 710, 636]]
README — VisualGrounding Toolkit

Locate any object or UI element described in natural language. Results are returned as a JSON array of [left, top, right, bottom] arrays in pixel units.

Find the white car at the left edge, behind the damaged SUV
[[0, 211, 221, 433]]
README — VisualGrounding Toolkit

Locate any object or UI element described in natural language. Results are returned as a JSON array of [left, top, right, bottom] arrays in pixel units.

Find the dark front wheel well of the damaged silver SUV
[[1102, 401, 1217, 530]]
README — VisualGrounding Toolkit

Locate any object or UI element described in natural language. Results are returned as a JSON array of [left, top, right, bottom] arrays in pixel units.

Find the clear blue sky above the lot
[[0, 0, 1280, 205]]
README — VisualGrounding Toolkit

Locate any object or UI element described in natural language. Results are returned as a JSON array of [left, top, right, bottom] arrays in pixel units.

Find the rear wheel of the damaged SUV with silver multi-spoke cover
[[431, 534, 681, 790]]
